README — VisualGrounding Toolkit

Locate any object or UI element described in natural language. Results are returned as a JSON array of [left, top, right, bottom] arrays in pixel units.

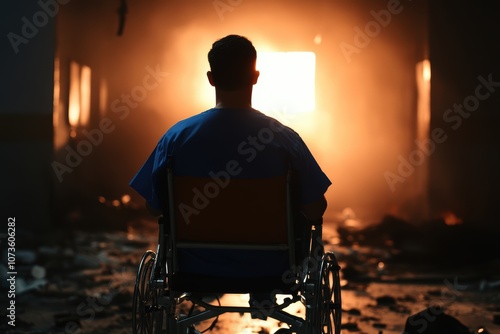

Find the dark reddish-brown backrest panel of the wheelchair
[[168, 169, 294, 272]]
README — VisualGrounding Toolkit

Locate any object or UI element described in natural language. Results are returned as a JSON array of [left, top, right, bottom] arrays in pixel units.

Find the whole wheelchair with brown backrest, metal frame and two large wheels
[[132, 165, 342, 334]]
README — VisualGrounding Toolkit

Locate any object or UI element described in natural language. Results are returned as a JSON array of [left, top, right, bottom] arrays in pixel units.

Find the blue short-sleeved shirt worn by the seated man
[[130, 108, 331, 277]]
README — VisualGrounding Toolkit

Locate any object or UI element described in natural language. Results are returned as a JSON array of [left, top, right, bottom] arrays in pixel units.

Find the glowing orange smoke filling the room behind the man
[[56, 0, 428, 226]]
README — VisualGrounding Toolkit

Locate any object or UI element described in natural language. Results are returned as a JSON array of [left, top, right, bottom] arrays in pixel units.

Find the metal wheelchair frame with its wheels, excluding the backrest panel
[[132, 163, 342, 334]]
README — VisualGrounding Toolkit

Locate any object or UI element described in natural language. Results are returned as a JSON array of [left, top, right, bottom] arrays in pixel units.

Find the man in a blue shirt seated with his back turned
[[130, 35, 331, 277]]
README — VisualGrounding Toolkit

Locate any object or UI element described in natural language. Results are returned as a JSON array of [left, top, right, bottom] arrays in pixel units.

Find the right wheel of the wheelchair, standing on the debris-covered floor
[[312, 252, 342, 334]]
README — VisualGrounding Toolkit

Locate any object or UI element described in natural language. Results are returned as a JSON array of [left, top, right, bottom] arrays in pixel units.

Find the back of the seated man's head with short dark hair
[[208, 35, 257, 90]]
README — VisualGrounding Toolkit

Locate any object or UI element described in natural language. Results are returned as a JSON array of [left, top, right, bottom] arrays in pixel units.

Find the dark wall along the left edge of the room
[[0, 0, 55, 235]]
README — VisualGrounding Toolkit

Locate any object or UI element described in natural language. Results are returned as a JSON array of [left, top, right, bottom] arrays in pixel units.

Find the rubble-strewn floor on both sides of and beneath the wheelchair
[[0, 214, 500, 334]]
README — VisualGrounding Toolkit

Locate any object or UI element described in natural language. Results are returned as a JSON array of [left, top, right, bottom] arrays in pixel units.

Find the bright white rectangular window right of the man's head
[[252, 52, 316, 114]]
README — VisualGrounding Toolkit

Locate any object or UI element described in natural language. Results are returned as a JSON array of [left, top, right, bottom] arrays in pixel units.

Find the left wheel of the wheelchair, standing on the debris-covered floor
[[132, 250, 166, 334]]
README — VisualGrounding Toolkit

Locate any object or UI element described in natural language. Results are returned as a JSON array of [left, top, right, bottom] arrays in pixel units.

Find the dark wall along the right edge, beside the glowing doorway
[[429, 1, 500, 226]]
